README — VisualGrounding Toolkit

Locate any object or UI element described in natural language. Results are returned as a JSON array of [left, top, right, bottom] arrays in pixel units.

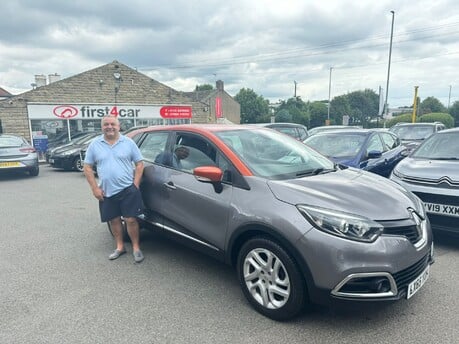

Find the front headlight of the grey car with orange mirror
[[297, 205, 384, 242]]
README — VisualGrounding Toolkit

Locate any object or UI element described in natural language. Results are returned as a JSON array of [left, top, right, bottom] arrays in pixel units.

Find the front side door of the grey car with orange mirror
[[157, 132, 233, 251]]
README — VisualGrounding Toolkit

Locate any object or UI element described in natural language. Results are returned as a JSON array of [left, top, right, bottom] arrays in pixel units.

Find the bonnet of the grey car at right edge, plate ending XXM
[[396, 157, 459, 182]]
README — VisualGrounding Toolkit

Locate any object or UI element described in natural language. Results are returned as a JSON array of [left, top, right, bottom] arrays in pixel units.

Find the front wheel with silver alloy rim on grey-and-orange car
[[237, 237, 307, 320]]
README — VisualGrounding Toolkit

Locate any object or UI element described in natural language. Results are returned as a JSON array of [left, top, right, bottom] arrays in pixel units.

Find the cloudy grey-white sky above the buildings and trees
[[0, 0, 459, 108]]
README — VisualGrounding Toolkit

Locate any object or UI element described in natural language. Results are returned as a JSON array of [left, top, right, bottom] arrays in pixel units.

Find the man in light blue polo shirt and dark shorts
[[84, 116, 144, 263]]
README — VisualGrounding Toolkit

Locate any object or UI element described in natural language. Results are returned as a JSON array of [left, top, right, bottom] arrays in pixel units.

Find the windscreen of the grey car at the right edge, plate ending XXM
[[411, 131, 459, 160]]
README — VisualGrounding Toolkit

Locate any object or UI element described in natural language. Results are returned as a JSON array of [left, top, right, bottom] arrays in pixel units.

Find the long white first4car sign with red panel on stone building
[[27, 103, 192, 119]]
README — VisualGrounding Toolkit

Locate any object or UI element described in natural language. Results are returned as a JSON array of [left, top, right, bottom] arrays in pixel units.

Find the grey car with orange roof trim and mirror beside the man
[[117, 124, 433, 320]]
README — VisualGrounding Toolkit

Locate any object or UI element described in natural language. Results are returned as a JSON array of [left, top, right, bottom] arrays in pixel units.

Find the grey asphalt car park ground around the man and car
[[0, 165, 459, 344]]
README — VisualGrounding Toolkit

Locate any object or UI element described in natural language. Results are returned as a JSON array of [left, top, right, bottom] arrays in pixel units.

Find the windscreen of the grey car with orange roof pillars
[[216, 129, 335, 180]]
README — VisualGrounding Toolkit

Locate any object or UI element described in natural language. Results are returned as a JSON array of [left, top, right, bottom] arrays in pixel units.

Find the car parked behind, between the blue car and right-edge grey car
[[389, 122, 446, 151]]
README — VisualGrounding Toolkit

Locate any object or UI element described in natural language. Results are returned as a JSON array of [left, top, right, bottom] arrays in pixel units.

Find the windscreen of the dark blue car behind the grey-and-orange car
[[304, 133, 366, 158]]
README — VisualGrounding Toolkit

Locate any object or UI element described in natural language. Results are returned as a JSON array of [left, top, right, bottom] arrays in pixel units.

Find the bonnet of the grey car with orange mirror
[[268, 168, 416, 221]]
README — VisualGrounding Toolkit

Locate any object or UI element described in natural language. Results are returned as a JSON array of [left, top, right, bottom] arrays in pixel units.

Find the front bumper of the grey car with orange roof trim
[[298, 221, 434, 303]]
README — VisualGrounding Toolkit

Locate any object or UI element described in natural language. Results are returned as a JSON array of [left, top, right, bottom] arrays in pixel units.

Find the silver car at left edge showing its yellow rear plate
[[0, 134, 40, 177]]
